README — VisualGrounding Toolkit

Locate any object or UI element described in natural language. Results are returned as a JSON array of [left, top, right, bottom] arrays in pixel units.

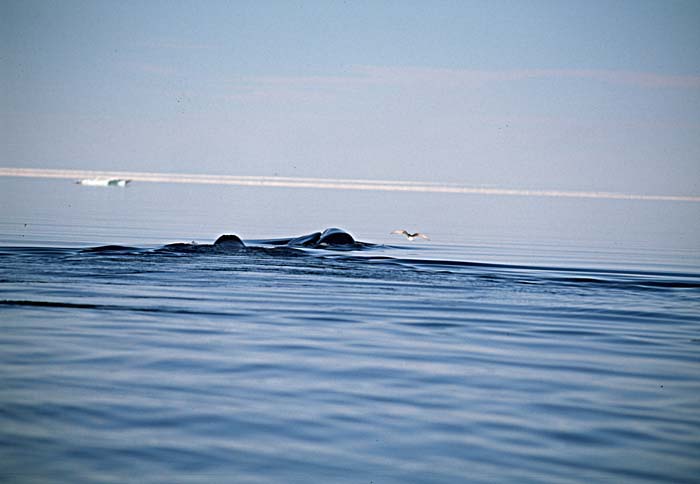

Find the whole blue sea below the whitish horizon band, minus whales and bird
[[0, 179, 700, 483]]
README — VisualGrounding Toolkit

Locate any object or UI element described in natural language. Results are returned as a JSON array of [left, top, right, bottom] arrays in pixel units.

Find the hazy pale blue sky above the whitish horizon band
[[0, 0, 700, 196]]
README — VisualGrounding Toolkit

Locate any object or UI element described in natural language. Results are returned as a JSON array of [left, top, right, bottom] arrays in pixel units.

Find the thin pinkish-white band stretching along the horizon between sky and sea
[[0, 167, 700, 202]]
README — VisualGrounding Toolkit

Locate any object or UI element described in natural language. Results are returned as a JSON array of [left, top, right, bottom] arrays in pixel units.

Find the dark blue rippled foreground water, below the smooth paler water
[[0, 246, 700, 483]]
